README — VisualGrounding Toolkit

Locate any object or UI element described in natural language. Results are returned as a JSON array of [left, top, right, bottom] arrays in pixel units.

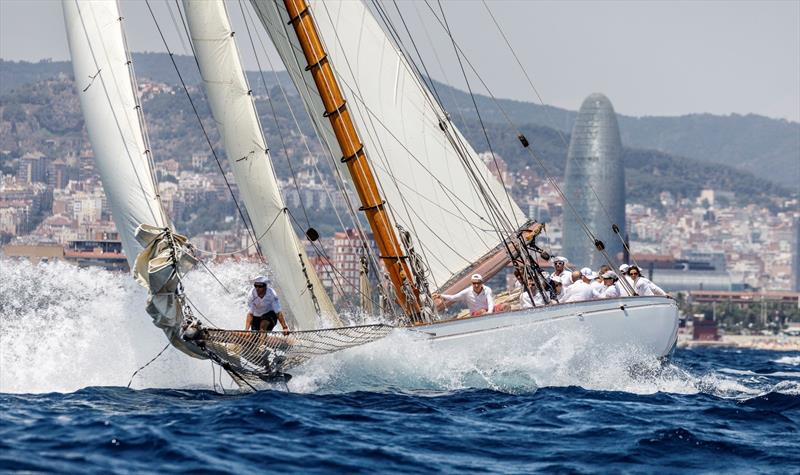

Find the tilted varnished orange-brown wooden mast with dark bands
[[284, 0, 419, 320]]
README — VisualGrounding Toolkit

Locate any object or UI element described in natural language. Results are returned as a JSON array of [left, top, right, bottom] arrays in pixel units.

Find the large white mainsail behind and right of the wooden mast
[[251, 0, 525, 286]]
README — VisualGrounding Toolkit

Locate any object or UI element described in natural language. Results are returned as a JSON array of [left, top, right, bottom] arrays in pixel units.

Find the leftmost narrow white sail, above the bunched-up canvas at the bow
[[62, 0, 169, 269]]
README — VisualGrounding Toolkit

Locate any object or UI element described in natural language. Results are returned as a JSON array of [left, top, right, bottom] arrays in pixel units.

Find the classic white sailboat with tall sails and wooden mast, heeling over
[[63, 0, 678, 389]]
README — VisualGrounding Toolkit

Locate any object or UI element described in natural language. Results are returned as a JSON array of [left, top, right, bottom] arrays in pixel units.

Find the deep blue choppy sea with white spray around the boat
[[0, 260, 800, 473]]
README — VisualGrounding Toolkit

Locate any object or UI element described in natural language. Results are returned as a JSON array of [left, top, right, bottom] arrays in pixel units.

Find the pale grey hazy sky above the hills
[[0, 0, 800, 121]]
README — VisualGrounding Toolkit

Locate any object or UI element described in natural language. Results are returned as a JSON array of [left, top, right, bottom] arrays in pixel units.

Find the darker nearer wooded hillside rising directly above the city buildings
[[0, 54, 789, 212]]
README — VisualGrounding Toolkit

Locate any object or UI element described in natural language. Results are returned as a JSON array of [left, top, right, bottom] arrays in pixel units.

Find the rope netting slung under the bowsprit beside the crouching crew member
[[195, 324, 394, 380]]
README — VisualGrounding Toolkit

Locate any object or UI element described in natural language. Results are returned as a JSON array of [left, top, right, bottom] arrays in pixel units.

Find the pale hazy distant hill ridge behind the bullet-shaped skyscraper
[[436, 83, 800, 191]]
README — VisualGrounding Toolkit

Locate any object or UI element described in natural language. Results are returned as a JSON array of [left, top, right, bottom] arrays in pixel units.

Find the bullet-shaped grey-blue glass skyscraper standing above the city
[[563, 93, 625, 269]]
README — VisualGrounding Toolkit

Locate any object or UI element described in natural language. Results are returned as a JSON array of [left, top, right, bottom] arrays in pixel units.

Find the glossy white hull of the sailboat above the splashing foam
[[408, 297, 678, 358]]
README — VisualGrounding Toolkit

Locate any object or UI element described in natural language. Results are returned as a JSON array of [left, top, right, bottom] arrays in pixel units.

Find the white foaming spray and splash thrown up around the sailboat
[[0, 260, 797, 399]]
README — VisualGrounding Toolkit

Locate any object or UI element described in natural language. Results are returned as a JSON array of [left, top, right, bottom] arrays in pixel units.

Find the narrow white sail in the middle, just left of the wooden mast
[[183, 0, 339, 330]]
